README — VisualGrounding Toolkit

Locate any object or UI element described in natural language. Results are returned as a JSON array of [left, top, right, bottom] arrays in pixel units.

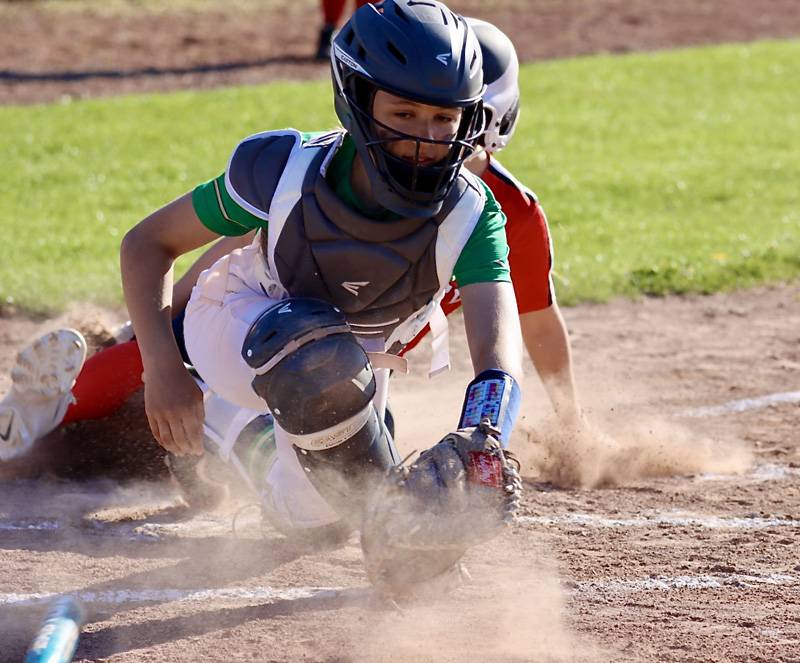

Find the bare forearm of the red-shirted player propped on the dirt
[[520, 305, 580, 420]]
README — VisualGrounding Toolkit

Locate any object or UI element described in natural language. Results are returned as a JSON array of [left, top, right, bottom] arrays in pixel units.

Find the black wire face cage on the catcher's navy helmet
[[343, 72, 484, 205]]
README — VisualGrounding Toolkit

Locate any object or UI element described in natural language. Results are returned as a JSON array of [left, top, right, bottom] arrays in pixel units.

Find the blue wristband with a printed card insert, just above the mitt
[[458, 368, 522, 447]]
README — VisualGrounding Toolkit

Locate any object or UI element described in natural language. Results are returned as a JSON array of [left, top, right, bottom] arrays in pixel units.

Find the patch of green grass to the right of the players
[[502, 42, 800, 302]]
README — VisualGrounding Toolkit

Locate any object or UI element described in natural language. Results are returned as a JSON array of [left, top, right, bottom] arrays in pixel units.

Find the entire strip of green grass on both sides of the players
[[0, 42, 800, 310]]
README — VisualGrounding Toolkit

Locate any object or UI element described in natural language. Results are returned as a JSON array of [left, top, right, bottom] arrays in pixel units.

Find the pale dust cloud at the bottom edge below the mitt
[[352, 554, 602, 663]]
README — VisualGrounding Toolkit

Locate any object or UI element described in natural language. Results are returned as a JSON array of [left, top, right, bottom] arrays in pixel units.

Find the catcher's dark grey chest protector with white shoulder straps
[[231, 132, 484, 350]]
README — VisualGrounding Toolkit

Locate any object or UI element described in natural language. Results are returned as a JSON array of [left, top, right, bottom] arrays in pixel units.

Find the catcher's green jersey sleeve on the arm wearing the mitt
[[453, 180, 511, 287]]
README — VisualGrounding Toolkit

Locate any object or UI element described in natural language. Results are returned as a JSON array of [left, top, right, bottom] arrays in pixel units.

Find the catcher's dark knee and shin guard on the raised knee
[[242, 298, 398, 515]]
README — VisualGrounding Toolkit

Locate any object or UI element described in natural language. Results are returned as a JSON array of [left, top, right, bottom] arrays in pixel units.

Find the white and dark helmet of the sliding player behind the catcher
[[467, 18, 519, 152]]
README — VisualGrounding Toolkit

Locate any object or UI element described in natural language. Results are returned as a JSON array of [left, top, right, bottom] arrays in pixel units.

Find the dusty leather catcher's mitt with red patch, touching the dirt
[[361, 420, 522, 597]]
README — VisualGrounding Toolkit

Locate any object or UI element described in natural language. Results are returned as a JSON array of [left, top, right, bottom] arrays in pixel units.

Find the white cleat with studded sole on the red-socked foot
[[0, 329, 86, 461]]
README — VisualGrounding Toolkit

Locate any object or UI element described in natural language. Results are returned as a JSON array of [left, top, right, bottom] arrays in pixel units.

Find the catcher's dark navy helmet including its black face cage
[[331, 0, 484, 217]]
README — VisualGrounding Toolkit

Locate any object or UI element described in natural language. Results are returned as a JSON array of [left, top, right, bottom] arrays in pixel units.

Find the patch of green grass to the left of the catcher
[[0, 82, 335, 310]]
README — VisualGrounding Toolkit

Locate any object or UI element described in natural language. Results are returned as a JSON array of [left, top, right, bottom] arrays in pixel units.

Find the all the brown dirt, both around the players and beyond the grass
[[0, 0, 800, 663]]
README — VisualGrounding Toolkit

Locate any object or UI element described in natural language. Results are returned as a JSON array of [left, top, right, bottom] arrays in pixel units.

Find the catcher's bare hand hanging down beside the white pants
[[144, 364, 204, 456]]
